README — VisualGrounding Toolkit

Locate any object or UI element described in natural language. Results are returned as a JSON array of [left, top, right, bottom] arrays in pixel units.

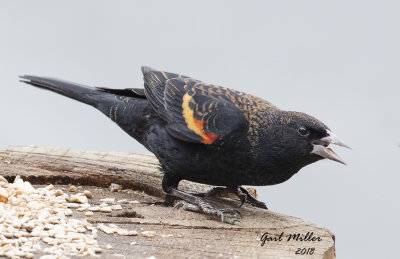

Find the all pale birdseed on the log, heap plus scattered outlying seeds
[[0, 176, 156, 259]]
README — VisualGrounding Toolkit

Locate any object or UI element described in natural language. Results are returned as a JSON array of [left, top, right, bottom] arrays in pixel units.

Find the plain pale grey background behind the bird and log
[[0, 0, 400, 258]]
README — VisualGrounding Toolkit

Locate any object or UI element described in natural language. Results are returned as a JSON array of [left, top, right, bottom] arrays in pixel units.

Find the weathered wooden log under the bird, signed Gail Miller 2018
[[0, 146, 335, 259]]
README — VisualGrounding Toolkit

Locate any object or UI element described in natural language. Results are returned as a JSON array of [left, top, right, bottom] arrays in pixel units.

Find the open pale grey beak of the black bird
[[311, 130, 350, 165]]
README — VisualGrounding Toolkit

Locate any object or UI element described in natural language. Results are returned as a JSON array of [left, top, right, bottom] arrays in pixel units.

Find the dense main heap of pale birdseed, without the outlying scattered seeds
[[0, 176, 102, 258]]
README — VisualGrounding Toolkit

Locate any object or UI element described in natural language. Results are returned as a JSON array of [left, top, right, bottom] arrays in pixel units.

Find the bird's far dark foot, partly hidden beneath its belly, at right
[[205, 186, 268, 209]]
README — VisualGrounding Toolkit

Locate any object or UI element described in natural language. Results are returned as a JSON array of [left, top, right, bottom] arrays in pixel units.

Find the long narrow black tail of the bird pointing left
[[20, 75, 114, 108]]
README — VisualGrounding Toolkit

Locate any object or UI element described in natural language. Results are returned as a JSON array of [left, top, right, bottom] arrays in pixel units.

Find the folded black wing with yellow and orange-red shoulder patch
[[144, 67, 248, 144]]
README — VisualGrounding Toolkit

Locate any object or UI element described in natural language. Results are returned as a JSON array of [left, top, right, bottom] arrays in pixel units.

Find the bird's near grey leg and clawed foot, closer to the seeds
[[168, 188, 242, 224]]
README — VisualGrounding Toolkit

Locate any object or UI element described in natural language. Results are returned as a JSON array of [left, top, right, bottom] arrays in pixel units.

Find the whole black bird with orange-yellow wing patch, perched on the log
[[21, 67, 347, 224]]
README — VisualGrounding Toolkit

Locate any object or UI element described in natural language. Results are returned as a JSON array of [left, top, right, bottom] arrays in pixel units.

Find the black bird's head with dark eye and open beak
[[272, 111, 350, 164]]
